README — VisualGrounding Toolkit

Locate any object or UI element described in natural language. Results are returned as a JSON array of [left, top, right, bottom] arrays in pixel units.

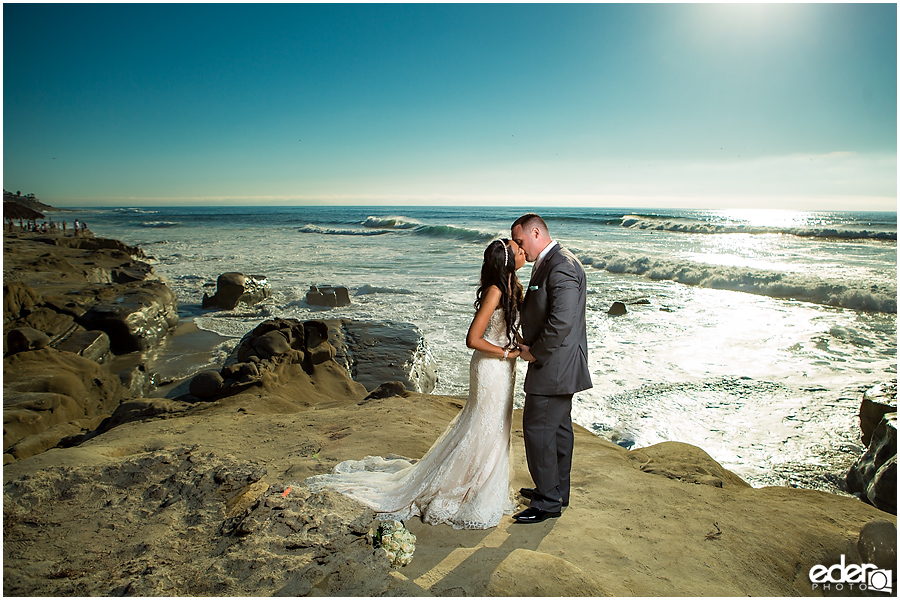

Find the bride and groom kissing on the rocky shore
[[306, 213, 591, 529]]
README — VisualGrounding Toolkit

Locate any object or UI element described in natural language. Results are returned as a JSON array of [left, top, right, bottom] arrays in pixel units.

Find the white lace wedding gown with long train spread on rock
[[306, 308, 516, 529]]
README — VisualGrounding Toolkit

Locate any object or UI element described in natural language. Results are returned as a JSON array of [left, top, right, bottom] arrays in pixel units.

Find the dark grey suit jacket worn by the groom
[[521, 245, 593, 396]]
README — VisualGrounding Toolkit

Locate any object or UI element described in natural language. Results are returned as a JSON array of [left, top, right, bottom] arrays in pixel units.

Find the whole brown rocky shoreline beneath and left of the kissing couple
[[3, 233, 896, 596]]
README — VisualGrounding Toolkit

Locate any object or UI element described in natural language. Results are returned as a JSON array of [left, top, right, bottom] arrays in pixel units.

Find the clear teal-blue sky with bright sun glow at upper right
[[3, 2, 897, 211]]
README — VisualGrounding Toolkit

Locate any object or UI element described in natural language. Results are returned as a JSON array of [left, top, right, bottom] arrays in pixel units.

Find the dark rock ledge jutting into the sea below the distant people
[[3, 233, 178, 356]]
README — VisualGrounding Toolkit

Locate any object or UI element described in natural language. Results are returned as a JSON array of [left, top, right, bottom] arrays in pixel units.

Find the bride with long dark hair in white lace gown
[[306, 239, 525, 529]]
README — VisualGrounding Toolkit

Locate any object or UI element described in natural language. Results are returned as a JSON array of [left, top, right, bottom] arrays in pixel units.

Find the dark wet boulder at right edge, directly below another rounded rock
[[846, 412, 897, 514]]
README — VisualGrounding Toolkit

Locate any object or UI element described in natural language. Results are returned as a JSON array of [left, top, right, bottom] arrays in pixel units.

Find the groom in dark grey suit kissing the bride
[[510, 213, 592, 523]]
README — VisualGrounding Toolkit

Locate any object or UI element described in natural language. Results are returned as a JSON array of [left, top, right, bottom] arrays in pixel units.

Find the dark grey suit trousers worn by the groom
[[522, 394, 575, 511]]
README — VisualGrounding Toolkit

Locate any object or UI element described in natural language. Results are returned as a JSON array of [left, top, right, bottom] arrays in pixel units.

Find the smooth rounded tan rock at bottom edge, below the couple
[[485, 548, 609, 597]]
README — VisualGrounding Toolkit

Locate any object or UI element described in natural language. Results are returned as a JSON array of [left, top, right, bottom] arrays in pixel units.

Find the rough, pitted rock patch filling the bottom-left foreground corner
[[3, 447, 391, 596]]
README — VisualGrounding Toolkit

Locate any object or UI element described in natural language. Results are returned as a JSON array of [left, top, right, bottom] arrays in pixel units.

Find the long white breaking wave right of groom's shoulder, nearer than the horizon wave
[[581, 254, 897, 313]]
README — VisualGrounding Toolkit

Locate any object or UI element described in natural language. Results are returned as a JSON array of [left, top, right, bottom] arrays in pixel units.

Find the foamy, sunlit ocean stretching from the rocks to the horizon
[[55, 206, 897, 492]]
